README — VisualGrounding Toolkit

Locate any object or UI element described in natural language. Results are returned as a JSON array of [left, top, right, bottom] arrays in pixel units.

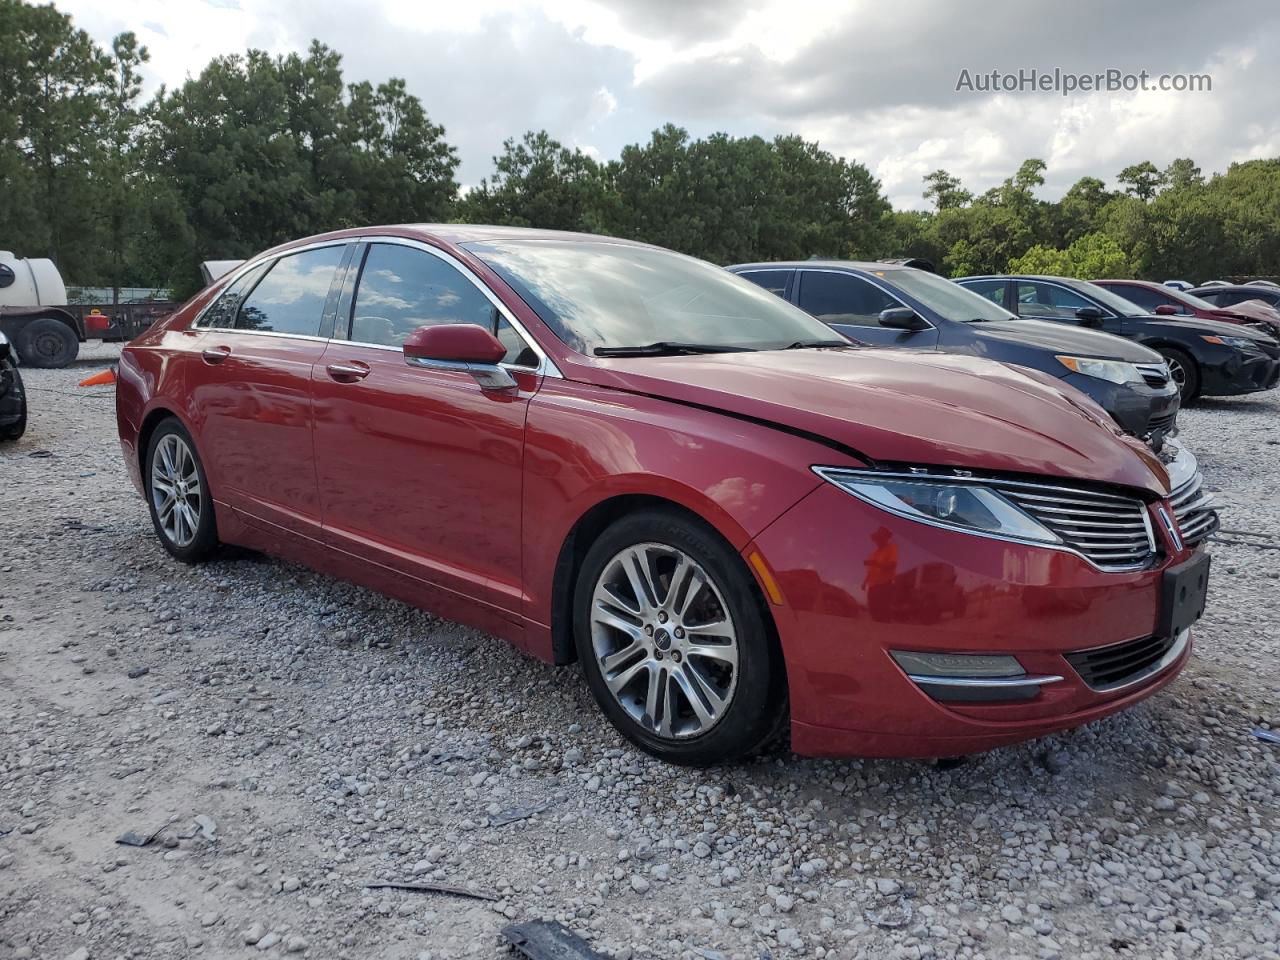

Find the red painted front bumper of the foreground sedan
[[746, 484, 1190, 756]]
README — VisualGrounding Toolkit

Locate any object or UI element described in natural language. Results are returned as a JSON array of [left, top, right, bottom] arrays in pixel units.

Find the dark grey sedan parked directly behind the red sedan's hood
[[728, 260, 1179, 447]]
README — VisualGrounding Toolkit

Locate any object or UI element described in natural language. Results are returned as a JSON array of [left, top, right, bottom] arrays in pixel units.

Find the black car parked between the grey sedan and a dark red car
[[956, 276, 1280, 403]]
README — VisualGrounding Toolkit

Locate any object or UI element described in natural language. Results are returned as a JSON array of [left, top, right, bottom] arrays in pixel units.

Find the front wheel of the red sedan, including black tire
[[573, 509, 786, 765]]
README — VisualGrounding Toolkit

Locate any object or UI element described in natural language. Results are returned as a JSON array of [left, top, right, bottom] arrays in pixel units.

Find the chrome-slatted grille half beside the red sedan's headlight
[[991, 480, 1156, 570]]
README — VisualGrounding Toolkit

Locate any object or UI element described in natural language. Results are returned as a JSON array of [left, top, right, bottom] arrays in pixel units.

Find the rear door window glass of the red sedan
[[236, 244, 346, 337]]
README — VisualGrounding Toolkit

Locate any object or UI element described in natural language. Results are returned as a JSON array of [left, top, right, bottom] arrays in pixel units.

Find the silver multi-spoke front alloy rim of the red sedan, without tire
[[590, 543, 739, 740]]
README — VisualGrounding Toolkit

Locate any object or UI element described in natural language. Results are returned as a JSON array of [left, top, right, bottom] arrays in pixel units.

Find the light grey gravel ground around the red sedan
[[0, 347, 1280, 960]]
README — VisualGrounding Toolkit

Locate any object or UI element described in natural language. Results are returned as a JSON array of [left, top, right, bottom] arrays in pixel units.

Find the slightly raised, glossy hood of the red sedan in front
[[586, 348, 1169, 495]]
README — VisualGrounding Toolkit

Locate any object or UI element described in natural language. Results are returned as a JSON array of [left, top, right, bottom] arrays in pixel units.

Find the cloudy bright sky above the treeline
[[56, 0, 1280, 207]]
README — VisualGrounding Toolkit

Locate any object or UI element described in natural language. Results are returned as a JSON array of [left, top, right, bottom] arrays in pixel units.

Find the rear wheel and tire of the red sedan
[[143, 417, 218, 563]]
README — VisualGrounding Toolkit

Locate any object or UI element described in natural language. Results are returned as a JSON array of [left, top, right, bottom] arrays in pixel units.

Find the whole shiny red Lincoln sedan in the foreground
[[116, 225, 1216, 763]]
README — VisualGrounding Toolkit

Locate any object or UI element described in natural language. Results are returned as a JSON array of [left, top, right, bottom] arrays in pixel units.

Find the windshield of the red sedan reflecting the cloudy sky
[[465, 239, 832, 355]]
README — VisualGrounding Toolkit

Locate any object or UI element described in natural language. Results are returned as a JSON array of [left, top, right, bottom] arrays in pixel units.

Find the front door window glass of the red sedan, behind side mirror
[[351, 243, 538, 366]]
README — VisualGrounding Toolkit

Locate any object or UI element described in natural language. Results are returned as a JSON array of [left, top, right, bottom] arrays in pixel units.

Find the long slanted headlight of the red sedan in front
[[814, 467, 1061, 543]]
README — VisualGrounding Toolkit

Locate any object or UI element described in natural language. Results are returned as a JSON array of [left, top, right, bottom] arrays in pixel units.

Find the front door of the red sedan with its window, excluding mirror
[[312, 242, 540, 622]]
